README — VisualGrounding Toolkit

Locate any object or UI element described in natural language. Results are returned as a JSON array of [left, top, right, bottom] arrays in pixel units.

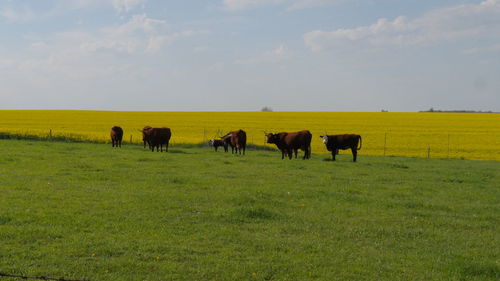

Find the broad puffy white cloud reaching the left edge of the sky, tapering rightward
[[0, 14, 207, 81]]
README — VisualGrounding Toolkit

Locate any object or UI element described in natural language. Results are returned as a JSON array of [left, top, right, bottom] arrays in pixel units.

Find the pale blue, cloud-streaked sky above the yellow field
[[0, 0, 500, 112]]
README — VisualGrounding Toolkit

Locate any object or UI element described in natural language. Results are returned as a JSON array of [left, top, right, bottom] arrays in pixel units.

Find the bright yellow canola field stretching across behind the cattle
[[0, 110, 500, 160]]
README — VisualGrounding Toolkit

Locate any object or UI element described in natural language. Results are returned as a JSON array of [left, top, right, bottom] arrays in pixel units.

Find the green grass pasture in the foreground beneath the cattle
[[0, 140, 500, 281]]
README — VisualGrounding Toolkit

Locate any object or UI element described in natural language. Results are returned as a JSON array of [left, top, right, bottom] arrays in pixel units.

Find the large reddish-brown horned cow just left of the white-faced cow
[[265, 130, 312, 159]]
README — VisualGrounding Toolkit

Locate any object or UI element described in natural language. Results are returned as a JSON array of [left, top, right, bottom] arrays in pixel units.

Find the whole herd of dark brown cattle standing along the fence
[[111, 126, 361, 162]]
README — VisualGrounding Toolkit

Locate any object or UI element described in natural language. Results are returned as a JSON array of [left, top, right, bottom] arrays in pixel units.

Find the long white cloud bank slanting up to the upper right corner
[[304, 0, 500, 51]]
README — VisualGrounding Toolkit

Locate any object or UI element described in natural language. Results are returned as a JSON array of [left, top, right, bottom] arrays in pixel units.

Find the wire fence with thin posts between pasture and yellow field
[[0, 127, 500, 161]]
